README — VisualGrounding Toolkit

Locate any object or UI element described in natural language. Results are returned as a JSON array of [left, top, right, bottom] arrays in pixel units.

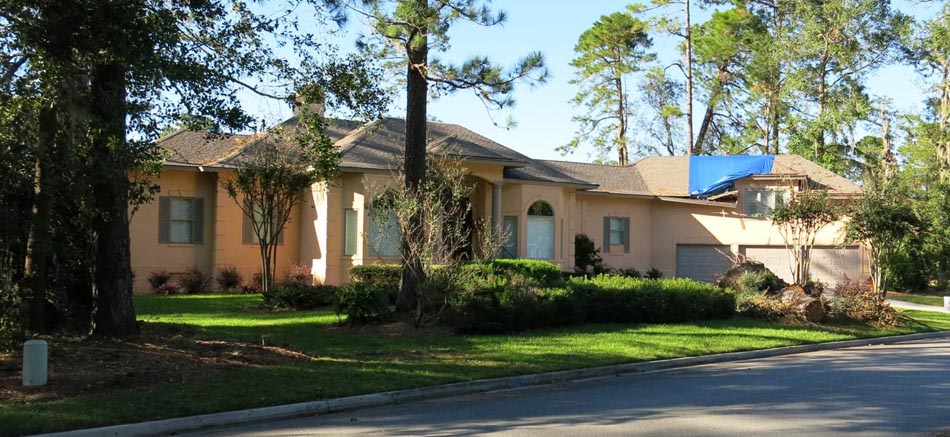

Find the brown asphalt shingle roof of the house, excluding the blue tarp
[[159, 118, 861, 197]]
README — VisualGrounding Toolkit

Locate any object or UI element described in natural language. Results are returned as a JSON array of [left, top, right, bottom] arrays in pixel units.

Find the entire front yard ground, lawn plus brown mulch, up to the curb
[[0, 295, 950, 435]]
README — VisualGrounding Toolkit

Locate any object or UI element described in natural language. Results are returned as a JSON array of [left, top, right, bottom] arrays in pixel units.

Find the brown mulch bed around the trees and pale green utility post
[[0, 324, 316, 404]]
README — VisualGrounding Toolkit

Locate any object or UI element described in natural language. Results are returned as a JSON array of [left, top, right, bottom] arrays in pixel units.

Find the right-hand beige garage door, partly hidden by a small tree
[[739, 246, 867, 286]]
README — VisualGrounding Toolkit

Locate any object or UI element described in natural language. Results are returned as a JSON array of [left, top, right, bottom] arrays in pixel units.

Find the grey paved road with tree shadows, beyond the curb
[[193, 339, 950, 437]]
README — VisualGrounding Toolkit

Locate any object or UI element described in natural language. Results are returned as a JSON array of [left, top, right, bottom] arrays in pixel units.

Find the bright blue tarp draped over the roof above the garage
[[689, 155, 775, 198]]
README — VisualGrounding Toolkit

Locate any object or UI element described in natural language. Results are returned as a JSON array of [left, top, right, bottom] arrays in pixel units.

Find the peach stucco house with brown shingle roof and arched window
[[131, 114, 868, 292]]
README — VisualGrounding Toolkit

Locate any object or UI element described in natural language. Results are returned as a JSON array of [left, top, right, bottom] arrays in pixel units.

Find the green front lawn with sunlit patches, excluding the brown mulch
[[0, 295, 950, 435]]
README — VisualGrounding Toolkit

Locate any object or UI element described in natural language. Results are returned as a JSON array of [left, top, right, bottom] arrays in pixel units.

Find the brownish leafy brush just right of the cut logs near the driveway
[[831, 281, 902, 328]]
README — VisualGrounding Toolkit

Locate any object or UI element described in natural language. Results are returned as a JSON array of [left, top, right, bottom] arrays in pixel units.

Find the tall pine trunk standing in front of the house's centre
[[396, 24, 429, 311]]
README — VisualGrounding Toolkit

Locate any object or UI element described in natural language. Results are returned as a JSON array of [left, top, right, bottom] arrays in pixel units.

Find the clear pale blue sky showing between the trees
[[244, 0, 939, 161]]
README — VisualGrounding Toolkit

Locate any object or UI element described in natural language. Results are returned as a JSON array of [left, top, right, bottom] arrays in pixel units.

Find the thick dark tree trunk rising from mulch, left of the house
[[90, 63, 139, 336]]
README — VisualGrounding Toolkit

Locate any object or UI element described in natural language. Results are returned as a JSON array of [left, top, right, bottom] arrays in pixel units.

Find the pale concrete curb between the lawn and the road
[[41, 331, 950, 437]]
